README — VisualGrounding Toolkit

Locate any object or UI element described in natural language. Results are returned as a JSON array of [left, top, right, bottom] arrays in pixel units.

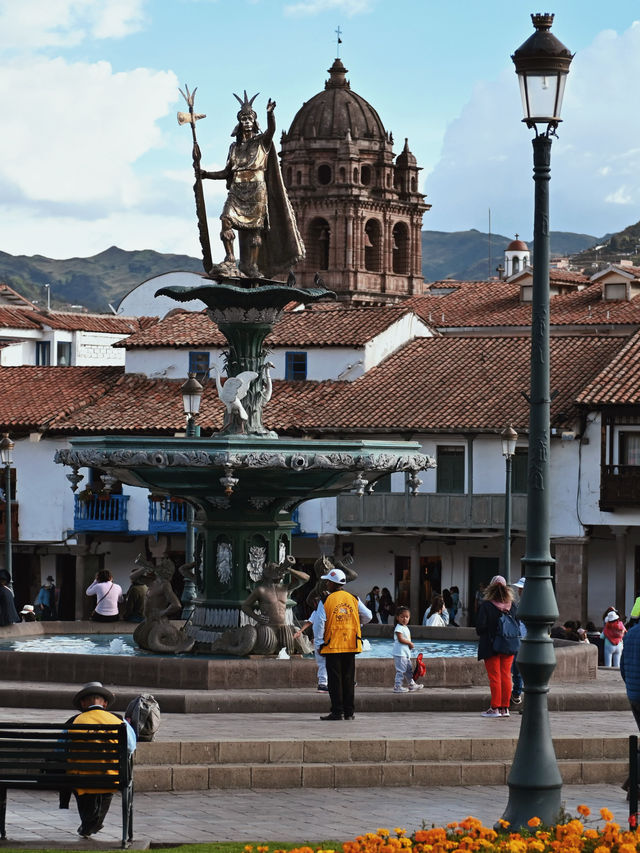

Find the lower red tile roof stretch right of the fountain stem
[[266, 336, 625, 433]]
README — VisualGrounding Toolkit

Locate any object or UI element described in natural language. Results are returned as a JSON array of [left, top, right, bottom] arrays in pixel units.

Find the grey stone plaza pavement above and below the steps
[[0, 669, 637, 850]]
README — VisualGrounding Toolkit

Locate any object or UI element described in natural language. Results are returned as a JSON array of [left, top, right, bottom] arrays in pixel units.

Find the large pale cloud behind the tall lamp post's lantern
[[424, 22, 640, 239]]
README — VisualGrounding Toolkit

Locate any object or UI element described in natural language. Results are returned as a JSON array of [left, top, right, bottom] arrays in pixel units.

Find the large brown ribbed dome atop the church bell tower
[[287, 59, 387, 141]]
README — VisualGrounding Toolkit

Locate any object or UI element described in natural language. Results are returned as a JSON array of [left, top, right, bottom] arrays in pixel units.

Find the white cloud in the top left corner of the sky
[[0, 0, 145, 51]]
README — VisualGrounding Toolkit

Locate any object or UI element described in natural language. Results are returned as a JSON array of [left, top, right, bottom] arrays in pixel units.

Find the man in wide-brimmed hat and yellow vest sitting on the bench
[[67, 681, 136, 838]]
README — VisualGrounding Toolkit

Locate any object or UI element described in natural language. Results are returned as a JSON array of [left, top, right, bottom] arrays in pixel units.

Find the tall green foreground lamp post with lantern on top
[[503, 14, 573, 828]]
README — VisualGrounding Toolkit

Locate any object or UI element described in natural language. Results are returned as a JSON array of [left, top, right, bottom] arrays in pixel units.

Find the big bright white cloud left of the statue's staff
[[0, 58, 177, 209]]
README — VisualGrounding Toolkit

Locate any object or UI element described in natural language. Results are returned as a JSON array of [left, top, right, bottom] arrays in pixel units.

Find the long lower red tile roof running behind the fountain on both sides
[[0, 335, 628, 435]]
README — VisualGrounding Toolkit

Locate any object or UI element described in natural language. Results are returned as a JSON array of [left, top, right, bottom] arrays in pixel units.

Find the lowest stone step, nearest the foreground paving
[[134, 758, 627, 791]]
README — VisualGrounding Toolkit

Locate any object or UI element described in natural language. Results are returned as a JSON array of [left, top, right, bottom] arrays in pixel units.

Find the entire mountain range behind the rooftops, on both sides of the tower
[[0, 222, 624, 311]]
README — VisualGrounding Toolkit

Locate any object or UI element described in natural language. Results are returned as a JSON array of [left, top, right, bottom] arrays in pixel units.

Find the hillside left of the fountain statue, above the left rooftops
[[0, 246, 203, 312]]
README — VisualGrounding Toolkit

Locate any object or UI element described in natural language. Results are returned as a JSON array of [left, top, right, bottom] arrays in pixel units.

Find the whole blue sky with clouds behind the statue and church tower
[[0, 0, 640, 259]]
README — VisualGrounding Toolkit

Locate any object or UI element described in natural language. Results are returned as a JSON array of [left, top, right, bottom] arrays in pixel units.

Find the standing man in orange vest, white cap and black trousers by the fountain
[[316, 568, 372, 720]]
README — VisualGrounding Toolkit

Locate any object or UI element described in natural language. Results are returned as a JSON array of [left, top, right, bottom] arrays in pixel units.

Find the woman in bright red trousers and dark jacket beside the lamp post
[[476, 575, 517, 717]]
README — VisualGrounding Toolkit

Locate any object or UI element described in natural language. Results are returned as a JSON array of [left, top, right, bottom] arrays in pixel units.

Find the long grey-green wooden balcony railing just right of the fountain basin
[[338, 493, 527, 531]]
